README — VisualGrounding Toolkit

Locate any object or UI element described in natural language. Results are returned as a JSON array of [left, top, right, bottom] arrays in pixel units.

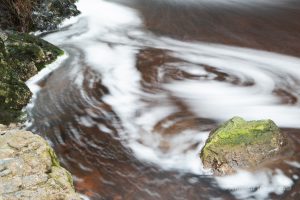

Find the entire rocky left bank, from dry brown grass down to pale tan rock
[[0, 0, 80, 200]]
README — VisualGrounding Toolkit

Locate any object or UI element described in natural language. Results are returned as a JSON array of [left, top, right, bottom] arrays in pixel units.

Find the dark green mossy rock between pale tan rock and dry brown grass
[[0, 31, 63, 124]]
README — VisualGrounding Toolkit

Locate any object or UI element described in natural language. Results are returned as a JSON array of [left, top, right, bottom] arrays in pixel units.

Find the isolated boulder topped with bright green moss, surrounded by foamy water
[[200, 117, 287, 175]]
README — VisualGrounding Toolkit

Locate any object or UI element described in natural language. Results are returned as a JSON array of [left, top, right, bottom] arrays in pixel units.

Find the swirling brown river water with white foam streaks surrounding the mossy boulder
[[28, 0, 300, 200]]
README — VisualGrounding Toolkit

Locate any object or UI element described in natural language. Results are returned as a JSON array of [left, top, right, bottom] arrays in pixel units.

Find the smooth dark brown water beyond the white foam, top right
[[120, 0, 300, 56]]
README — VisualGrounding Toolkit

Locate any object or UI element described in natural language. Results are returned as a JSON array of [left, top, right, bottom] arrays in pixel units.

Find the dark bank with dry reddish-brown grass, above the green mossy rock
[[0, 0, 79, 32]]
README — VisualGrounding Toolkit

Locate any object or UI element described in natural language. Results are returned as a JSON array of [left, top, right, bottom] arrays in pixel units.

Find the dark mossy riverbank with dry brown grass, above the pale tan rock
[[0, 0, 79, 124]]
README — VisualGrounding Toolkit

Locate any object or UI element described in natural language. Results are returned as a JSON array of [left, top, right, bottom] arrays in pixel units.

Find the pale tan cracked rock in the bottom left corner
[[0, 125, 80, 200]]
